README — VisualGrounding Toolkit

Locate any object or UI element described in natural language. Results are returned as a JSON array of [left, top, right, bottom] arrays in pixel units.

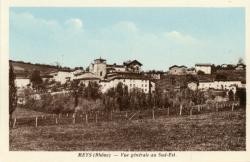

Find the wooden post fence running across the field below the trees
[[10, 102, 239, 128]]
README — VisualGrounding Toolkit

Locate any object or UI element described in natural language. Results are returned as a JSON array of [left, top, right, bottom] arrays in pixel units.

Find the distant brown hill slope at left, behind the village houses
[[9, 60, 70, 77]]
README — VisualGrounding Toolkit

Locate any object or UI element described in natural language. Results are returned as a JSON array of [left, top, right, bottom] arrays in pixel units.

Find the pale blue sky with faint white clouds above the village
[[9, 7, 245, 71]]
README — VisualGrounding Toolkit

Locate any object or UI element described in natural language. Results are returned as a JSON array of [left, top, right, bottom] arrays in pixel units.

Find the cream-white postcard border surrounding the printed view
[[0, 0, 250, 162]]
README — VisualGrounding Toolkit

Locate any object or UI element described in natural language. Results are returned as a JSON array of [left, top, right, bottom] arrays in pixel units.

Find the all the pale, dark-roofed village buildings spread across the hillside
[[14, 58, 245, 93]]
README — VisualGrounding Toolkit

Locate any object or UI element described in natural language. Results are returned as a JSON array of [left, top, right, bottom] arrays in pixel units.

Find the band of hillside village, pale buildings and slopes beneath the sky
[[10, 58, 246, 106]]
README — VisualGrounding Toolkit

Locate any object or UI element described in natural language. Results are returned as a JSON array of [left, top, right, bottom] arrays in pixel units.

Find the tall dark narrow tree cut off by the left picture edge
[[9, 64, 17, 123]]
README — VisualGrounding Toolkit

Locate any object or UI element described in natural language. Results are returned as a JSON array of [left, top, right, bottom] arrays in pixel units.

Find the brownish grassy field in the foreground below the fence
[[10, 110, 246, 151]]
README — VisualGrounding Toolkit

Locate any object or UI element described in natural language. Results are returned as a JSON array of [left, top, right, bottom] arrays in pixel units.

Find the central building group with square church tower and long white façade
[[84, 58, 155, 93]]
